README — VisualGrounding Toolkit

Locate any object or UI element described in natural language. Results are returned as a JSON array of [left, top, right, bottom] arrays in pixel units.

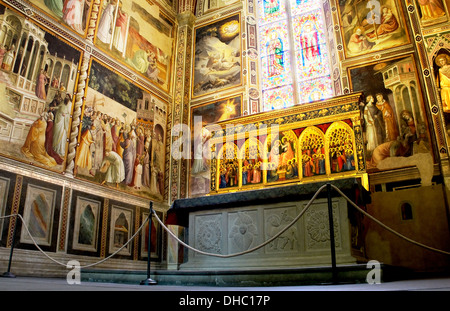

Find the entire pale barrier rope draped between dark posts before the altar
[[0, 184, 450, 269]]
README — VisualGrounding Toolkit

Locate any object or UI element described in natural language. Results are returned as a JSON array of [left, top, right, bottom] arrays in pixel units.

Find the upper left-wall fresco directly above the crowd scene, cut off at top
[[95, 0, 175, 91]]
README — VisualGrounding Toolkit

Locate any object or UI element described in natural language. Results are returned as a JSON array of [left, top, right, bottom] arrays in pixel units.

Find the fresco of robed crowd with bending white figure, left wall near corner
[[75, 60, 167, 199]]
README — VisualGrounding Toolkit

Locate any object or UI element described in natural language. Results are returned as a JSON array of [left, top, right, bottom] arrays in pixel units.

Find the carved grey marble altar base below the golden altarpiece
[[168, 178, 359, 270]]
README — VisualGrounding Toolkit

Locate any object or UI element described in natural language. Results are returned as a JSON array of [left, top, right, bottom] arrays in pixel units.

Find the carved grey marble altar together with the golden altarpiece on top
[[167, 93, 367, 269]]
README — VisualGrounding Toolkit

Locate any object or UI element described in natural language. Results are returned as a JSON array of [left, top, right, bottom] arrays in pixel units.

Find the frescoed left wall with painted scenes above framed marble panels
[[0, 0, 177, 276]]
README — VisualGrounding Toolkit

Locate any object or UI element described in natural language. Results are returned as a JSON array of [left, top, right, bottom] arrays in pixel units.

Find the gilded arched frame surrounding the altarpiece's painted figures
[[210, 93, 367, 194]]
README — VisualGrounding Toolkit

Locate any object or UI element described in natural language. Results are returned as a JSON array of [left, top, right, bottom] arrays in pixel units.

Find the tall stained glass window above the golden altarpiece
[[258, 0, 333, 111]]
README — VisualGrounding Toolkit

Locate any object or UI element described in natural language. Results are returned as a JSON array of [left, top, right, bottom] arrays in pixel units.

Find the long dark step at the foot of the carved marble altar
[[81, 264, 409, 287]]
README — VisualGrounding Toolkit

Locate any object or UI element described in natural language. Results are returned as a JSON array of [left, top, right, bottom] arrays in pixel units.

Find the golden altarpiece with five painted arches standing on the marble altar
[[209, 93, 367, 194]]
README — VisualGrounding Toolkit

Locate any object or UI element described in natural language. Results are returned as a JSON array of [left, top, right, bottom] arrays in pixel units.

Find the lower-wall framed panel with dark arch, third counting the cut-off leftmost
[[72, 196, 102, 252]]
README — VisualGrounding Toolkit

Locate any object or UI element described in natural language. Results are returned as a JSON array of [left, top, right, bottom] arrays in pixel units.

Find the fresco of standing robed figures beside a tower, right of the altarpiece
[[349, 55, 433, 172]]
